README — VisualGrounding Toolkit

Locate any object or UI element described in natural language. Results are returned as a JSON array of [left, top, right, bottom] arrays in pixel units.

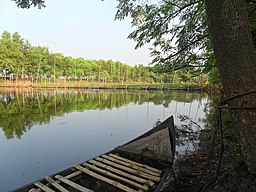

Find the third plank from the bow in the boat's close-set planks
[[95, 157, 161, 182]]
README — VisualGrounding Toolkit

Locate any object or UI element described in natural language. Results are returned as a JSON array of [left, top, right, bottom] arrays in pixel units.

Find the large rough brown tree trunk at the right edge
[[205, 0, 256, 173]]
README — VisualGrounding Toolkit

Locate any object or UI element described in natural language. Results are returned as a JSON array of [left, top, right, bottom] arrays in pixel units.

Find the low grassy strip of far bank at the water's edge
[[0, 81, 202, 91]]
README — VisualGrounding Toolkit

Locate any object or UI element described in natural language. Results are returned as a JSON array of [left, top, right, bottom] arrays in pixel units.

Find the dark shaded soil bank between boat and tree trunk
[[162, 124, 256, 192]]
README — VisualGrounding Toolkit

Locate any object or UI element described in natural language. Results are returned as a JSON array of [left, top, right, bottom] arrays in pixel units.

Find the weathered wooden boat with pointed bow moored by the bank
[[13, 116, 175, 192]]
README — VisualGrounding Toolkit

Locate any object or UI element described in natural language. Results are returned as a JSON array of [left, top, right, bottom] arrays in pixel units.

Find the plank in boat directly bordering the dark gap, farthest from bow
[[74, 165, 137, 192]]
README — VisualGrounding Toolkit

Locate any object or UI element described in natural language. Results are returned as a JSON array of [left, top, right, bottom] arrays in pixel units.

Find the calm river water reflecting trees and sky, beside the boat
[[0, 89, 210, 192]]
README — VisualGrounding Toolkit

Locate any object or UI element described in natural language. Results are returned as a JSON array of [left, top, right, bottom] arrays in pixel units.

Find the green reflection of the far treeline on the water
[[0, 89, 206, 139]]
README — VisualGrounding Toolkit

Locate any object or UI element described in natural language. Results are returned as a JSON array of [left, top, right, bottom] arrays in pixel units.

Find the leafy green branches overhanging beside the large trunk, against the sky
[[116, 0, 211, 74]]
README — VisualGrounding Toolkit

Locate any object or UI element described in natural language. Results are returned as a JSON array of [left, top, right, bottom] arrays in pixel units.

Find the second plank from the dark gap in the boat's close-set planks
[[83, 163, 148, 191]]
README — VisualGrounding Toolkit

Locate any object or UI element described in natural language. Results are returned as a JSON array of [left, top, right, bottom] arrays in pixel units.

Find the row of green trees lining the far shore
[[0, 31, 210, 83]]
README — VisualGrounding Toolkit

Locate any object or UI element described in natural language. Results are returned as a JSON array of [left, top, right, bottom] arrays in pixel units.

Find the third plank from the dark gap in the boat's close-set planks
[[89, 160, 155, 187]]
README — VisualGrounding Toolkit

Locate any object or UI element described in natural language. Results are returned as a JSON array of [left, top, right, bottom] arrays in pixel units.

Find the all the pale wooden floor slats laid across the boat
[[32, 154, 162, 192]]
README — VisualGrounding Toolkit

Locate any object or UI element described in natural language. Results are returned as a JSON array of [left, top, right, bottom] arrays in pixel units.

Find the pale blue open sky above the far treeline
[[0, 0, 150, 65]]
